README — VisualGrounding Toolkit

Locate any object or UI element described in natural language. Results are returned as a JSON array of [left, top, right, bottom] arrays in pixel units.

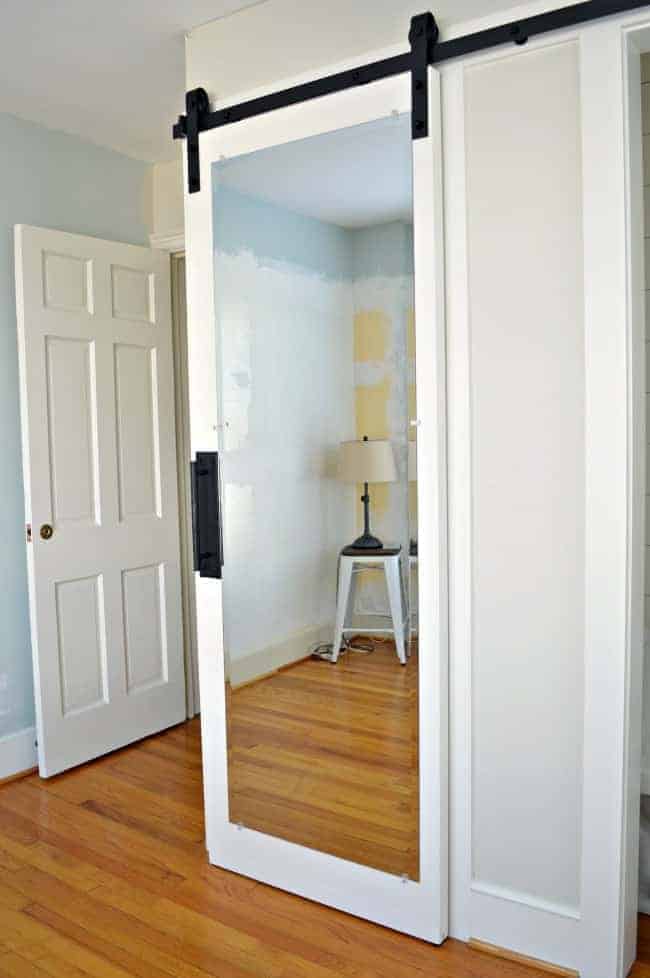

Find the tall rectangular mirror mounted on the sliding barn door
[[213, 116, 419, 879]]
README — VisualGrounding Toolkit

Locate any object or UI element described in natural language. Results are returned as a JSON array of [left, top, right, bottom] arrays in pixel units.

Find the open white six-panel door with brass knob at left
[[15, 225, 185, 777]]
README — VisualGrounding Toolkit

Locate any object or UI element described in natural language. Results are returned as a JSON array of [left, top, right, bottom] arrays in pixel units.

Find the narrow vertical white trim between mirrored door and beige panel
[[442, 55, 473, 941]]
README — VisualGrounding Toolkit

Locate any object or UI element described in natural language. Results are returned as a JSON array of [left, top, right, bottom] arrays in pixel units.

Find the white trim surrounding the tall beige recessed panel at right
[[442, 11, 650, 978]]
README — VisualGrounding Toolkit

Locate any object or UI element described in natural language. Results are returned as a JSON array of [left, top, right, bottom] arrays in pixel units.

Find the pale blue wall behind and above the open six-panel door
[[0, 114, 149, 737]]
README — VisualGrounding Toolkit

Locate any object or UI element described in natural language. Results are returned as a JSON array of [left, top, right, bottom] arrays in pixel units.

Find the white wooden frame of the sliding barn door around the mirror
[[185, 69, 448, 943]]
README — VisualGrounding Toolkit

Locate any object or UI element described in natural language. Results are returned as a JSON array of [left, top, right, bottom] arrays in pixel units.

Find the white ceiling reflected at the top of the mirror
[[216, 115, 412, 228]]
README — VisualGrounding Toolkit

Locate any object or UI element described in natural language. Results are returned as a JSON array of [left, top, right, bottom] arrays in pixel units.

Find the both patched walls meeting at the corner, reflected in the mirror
[[214, 173, 414, 685]]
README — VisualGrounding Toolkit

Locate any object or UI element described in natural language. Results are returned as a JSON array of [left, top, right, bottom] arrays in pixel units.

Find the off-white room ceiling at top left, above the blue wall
[[0, 0, 519, 161]]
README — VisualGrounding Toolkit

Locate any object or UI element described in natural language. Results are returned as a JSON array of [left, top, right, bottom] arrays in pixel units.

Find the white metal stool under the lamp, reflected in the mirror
[[332, 547, 407, 666]]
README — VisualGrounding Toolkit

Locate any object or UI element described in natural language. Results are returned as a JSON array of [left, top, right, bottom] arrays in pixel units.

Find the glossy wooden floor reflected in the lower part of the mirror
[[229, 641, 419, 879]]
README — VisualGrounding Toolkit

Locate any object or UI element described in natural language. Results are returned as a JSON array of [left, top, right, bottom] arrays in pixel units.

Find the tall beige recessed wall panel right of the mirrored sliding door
[[465, 42, 585, 910]]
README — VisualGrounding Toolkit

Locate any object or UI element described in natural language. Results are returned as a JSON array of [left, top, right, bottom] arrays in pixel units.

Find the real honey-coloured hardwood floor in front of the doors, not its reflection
[[0, 708, 560, 978]]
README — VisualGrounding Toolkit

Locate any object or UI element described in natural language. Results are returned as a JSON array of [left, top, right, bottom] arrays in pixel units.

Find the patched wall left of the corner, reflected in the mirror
[[214, 183, 354, 685]]
